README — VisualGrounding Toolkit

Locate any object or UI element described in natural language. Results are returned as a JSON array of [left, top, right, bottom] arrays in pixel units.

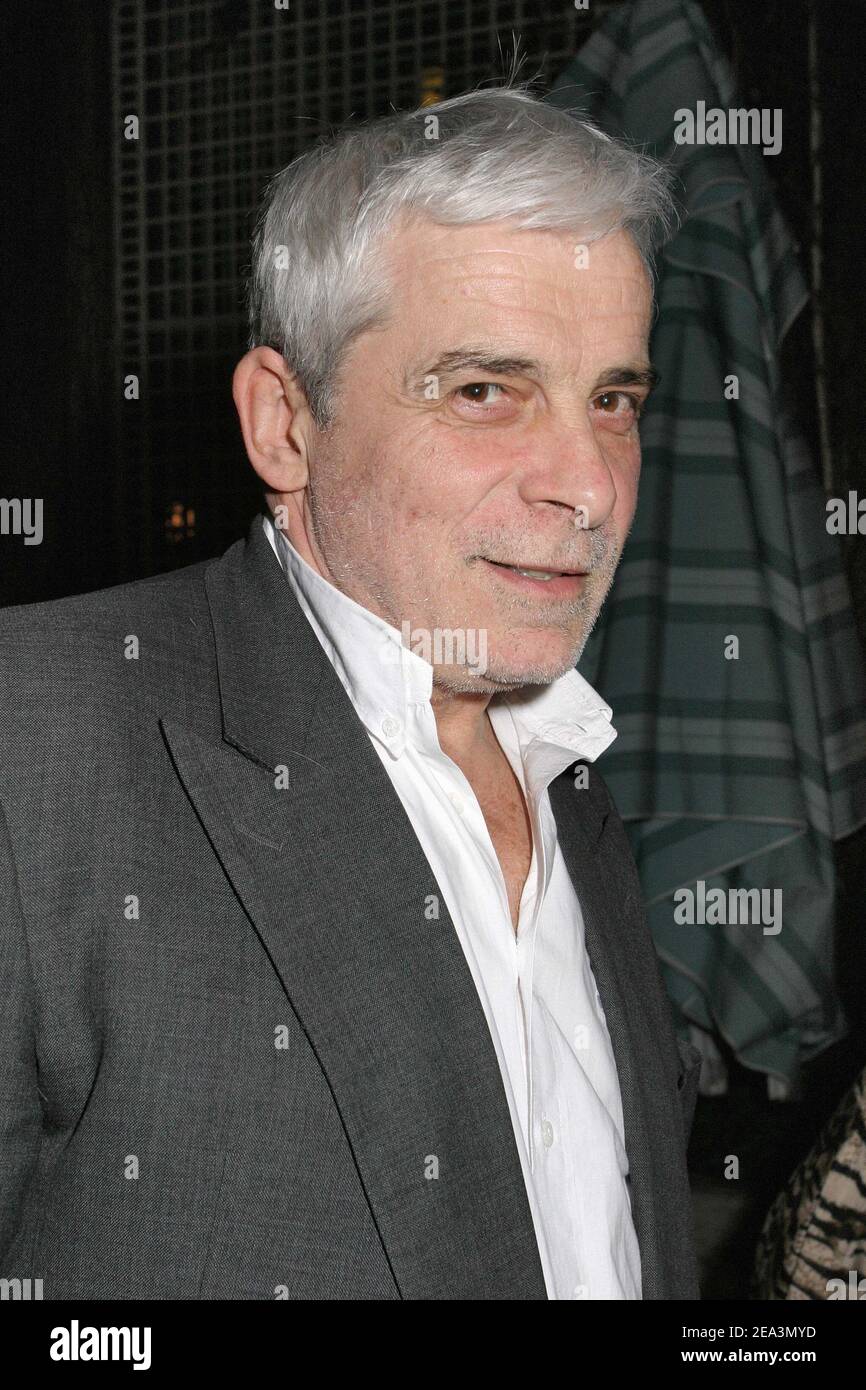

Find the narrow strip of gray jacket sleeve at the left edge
[[0, 803, 42, 1275]]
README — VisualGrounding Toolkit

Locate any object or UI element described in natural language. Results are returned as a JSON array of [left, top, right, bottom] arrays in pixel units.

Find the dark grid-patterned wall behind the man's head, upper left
[[113, 0, 609, 574]]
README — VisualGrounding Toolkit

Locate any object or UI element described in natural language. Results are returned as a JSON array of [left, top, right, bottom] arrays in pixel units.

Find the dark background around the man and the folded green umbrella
[[0, 0, 866, 1298]]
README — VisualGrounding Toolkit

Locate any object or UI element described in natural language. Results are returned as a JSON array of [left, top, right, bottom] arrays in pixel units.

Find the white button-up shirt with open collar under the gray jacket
[[264, 516, 641, 1298]]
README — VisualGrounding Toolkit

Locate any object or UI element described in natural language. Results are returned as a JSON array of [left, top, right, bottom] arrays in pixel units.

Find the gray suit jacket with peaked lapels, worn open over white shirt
[[0, 517, 698, 1300]]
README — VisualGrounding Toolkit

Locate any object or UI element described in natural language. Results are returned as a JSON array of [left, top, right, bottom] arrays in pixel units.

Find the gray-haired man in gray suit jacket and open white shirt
[[0, 89, 706, 1300]]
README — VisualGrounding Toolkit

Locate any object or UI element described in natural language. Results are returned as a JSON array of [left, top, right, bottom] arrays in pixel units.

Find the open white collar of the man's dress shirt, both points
[[263, 514, 616, 781]]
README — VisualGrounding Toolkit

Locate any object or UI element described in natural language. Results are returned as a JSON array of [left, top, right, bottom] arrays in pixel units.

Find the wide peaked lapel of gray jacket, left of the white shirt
[[163, 517, 546, 1300]]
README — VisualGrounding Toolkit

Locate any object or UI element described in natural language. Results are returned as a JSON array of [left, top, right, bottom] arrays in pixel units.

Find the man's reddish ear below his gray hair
[[232, 346, 313, 493]]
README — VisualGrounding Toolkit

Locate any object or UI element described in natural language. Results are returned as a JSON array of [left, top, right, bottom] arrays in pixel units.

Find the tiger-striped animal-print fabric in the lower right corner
[[753, 1070, 866, 1301]]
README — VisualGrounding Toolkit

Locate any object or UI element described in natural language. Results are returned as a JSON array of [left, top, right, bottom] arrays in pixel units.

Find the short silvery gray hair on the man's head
[[247, 83, 676, 430]]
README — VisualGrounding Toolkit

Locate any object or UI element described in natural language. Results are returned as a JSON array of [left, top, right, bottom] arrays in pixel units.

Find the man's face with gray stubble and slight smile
[[297, 221, 651, 692]]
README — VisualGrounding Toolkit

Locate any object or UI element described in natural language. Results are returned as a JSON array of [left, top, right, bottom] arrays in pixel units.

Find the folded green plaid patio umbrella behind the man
[[548, 0, 866, 1095]]
